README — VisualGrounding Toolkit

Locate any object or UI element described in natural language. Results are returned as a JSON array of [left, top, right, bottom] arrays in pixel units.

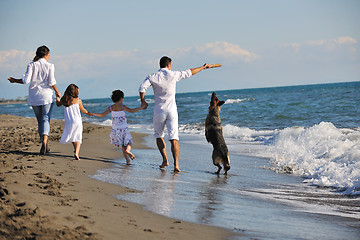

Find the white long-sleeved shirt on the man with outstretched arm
[[139, 68, 192, 113]]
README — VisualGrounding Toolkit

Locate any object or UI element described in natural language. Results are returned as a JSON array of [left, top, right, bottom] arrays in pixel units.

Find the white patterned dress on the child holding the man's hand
[[110, 106, 133, 147]]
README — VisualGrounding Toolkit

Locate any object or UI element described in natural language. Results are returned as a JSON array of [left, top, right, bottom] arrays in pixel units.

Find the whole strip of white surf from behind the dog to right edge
[[179, 122, 360, 195]]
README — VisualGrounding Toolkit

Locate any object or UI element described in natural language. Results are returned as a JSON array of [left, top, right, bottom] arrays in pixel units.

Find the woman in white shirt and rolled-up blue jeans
[[8, 46, 61, 155]]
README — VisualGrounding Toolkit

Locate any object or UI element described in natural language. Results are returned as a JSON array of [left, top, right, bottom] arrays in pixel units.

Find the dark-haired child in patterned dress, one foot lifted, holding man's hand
[[92, 90, 144, 165]]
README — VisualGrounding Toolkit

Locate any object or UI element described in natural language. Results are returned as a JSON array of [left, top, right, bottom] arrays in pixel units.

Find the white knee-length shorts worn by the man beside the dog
[[153, 111, 179, 140]]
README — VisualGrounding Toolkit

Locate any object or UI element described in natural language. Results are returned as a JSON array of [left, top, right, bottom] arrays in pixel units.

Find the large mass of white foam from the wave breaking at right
[[266, 122, 360, 194]]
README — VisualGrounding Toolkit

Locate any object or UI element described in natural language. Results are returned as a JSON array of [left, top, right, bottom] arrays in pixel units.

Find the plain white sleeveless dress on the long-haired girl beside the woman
[[60, 103, 83, 143]]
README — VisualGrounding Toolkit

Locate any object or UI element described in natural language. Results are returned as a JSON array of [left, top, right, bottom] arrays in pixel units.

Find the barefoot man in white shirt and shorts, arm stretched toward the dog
[[139, 56, 209, 172]]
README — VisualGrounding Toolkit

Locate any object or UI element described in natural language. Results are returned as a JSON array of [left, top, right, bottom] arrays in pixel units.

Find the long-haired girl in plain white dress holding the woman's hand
[[56, 84, 91, 160]]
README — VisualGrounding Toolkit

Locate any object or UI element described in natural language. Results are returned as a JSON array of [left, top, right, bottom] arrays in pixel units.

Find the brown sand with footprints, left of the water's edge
[[0, 115, 232, 240]]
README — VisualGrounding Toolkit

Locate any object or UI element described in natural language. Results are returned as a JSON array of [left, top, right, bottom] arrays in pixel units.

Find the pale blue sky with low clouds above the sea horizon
[[0, 0, 360, 99]]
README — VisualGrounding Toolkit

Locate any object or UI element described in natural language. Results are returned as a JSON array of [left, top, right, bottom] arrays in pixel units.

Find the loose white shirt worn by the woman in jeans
[[22, 58, 56, 106]]
